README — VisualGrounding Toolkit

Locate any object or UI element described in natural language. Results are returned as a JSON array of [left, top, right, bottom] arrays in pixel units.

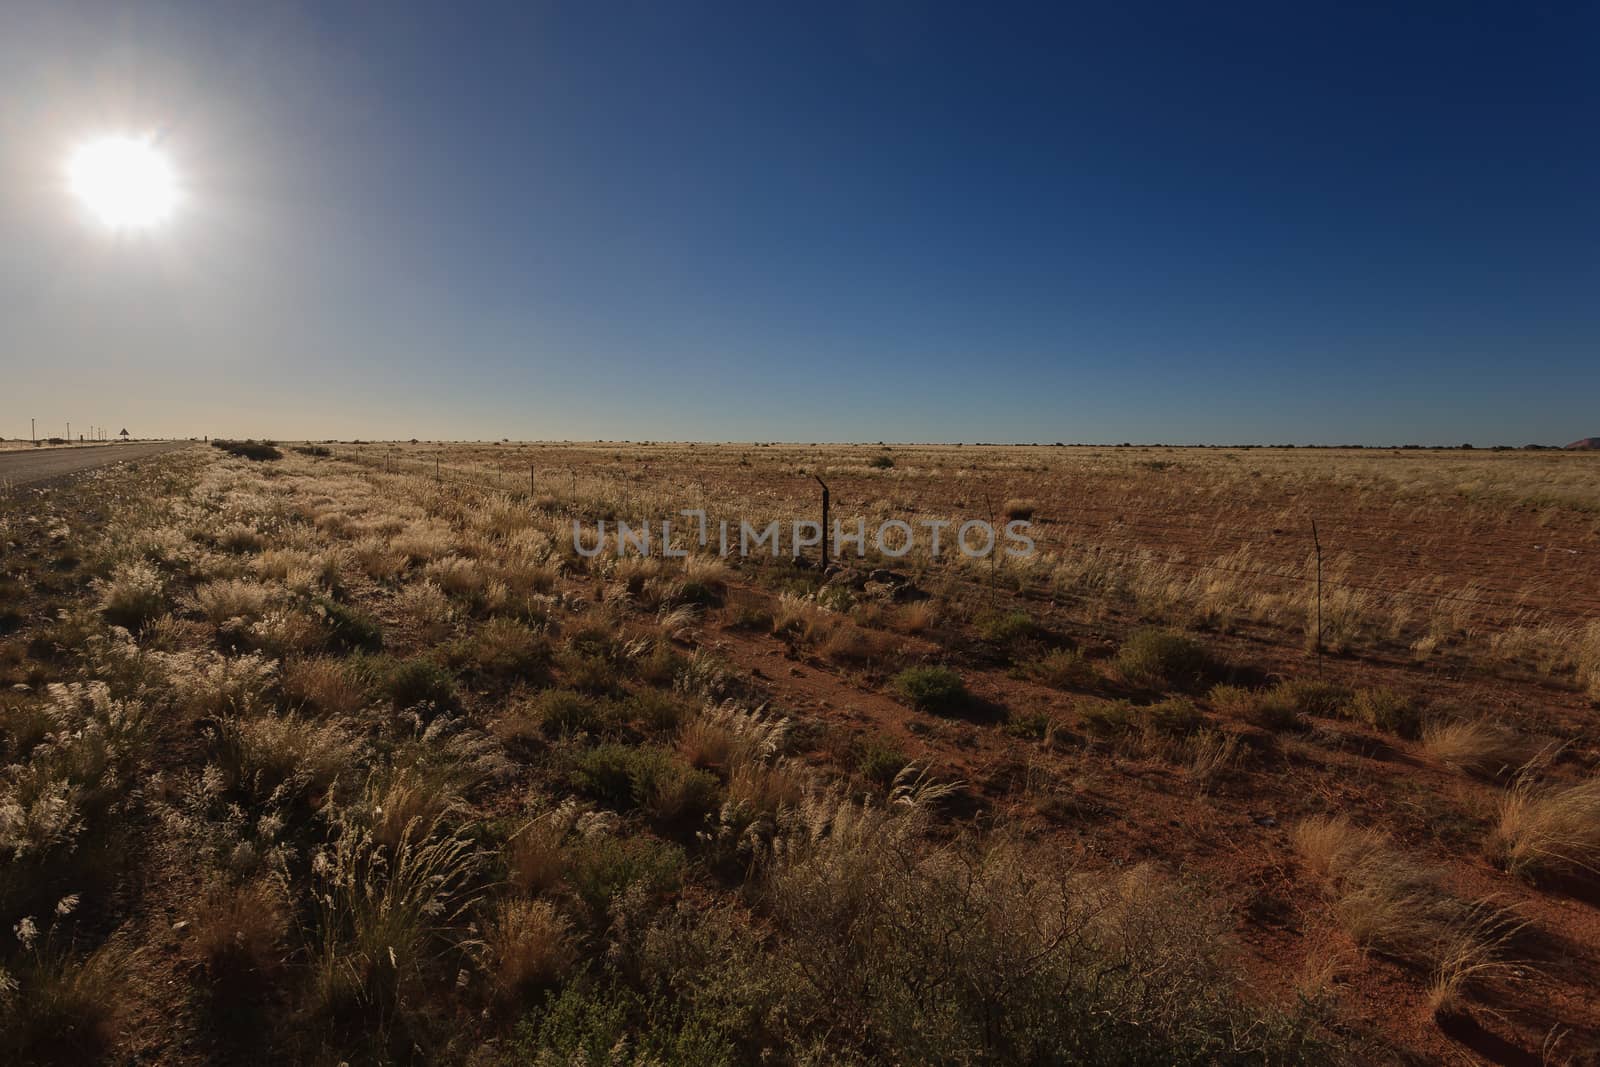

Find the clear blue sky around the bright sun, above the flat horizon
[[0, 0, 1600, 445]]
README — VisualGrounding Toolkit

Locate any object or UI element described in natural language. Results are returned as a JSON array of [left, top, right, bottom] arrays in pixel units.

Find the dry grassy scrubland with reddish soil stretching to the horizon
[[0, 445, 1600, 1064]]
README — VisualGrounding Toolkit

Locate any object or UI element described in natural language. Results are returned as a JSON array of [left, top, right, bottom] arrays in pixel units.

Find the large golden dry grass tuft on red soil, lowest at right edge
[[1490, 774, 1600, 878]]
